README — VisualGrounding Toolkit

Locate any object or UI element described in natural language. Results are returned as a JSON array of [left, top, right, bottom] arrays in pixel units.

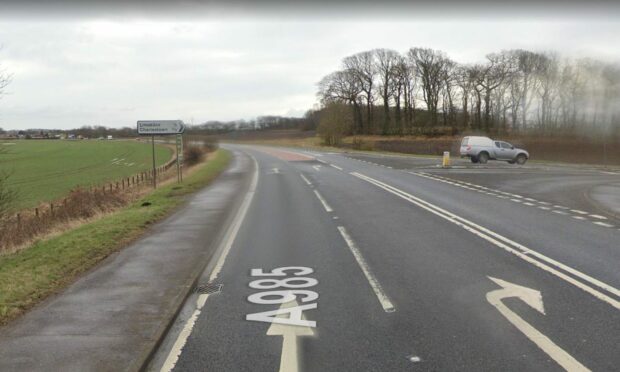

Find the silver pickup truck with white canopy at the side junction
[[460, 136, 530, 165]]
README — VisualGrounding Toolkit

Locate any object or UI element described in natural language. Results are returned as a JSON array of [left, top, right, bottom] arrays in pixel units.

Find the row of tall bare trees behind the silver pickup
[[317, 48, 620, 136]]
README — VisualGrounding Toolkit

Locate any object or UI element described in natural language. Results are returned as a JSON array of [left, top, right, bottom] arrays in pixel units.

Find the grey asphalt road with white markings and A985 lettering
[[150, 145, 620, 371]]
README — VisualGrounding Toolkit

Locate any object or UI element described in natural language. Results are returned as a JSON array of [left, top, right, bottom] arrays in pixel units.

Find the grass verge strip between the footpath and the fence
[[0, 150, 231, 324]]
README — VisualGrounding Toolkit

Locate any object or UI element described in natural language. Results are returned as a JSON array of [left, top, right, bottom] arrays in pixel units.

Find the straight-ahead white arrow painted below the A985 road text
[[267, 300, 314, 372]]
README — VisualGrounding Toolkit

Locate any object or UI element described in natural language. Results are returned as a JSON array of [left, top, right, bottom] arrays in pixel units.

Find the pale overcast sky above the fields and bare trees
[[0, 0, 620, 130]]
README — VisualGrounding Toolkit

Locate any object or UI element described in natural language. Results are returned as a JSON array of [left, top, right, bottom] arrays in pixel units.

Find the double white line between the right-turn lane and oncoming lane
[[350, 172, 620, 309]]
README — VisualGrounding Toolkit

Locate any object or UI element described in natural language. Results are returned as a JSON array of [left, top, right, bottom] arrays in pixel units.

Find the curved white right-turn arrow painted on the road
[[487, 276, 589, 371]]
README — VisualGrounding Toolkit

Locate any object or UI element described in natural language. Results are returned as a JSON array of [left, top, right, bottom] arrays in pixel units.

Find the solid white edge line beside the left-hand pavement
[[160, 154, 258, 372]]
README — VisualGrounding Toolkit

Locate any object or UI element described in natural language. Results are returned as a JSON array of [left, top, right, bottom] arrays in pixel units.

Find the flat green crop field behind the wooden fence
[[0, 140, 172, 209]]
